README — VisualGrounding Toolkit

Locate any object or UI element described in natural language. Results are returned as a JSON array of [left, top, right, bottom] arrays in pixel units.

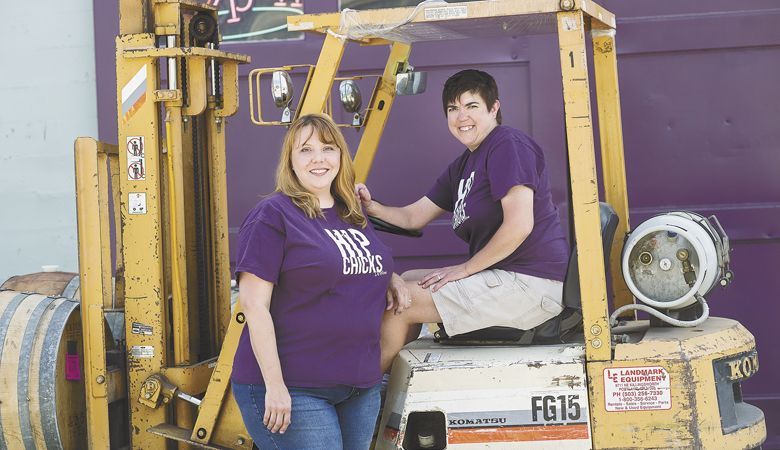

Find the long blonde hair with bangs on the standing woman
[[276, 114, 366, 228]]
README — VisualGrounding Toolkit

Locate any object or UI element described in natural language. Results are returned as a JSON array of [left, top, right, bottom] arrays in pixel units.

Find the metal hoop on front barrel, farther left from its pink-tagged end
[[16, 297, 54, 449]]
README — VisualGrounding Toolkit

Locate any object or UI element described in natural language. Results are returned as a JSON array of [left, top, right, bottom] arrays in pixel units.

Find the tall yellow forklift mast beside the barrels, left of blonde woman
[[76, 0, 251, 448]]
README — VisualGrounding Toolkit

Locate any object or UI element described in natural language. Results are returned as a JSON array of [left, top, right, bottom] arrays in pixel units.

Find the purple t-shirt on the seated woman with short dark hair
[[426, 126, 569, 281]]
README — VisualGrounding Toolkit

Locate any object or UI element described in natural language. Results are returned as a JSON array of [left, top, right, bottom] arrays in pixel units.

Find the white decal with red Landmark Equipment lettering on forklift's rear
[[604, 366, 672, 412]]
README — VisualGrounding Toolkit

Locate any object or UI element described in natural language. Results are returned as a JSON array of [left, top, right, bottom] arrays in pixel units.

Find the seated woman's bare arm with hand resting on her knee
[[420, 185, 534, 292]]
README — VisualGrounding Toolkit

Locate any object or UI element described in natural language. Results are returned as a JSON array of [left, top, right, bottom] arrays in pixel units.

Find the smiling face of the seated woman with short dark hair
[[447, 92, 500, 152]]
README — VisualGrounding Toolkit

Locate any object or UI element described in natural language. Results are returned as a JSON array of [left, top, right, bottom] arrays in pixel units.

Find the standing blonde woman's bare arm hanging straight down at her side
[[238, 272, 292, 433]]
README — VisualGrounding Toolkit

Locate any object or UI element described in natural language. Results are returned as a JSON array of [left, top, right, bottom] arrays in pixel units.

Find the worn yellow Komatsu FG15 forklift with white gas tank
[[0, 0, 766, 449]]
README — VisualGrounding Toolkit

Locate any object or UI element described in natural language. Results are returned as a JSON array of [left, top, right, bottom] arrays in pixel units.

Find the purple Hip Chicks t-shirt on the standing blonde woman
[[231, 193, 393, 387]]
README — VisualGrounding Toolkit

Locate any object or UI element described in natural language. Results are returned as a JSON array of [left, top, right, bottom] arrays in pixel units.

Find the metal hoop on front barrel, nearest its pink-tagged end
[[38, 298, 79, 450]]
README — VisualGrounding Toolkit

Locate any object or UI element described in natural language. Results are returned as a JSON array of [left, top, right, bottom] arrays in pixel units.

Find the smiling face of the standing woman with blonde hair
[[290, 125, 341, 207]]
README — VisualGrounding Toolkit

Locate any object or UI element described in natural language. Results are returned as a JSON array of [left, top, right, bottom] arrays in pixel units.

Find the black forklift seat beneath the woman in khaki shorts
[[434, 202, 618, 345]]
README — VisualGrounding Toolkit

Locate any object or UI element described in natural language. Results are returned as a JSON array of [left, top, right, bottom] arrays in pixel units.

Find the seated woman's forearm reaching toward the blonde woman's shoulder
[[355, 183, 444, 230]]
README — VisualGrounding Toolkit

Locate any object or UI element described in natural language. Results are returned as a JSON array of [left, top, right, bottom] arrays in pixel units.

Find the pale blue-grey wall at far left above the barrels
[[0, 0, 97, 282]]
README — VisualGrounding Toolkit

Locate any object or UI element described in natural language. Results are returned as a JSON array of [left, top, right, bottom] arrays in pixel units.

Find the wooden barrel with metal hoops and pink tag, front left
[[0, 290, 87, 450]]
